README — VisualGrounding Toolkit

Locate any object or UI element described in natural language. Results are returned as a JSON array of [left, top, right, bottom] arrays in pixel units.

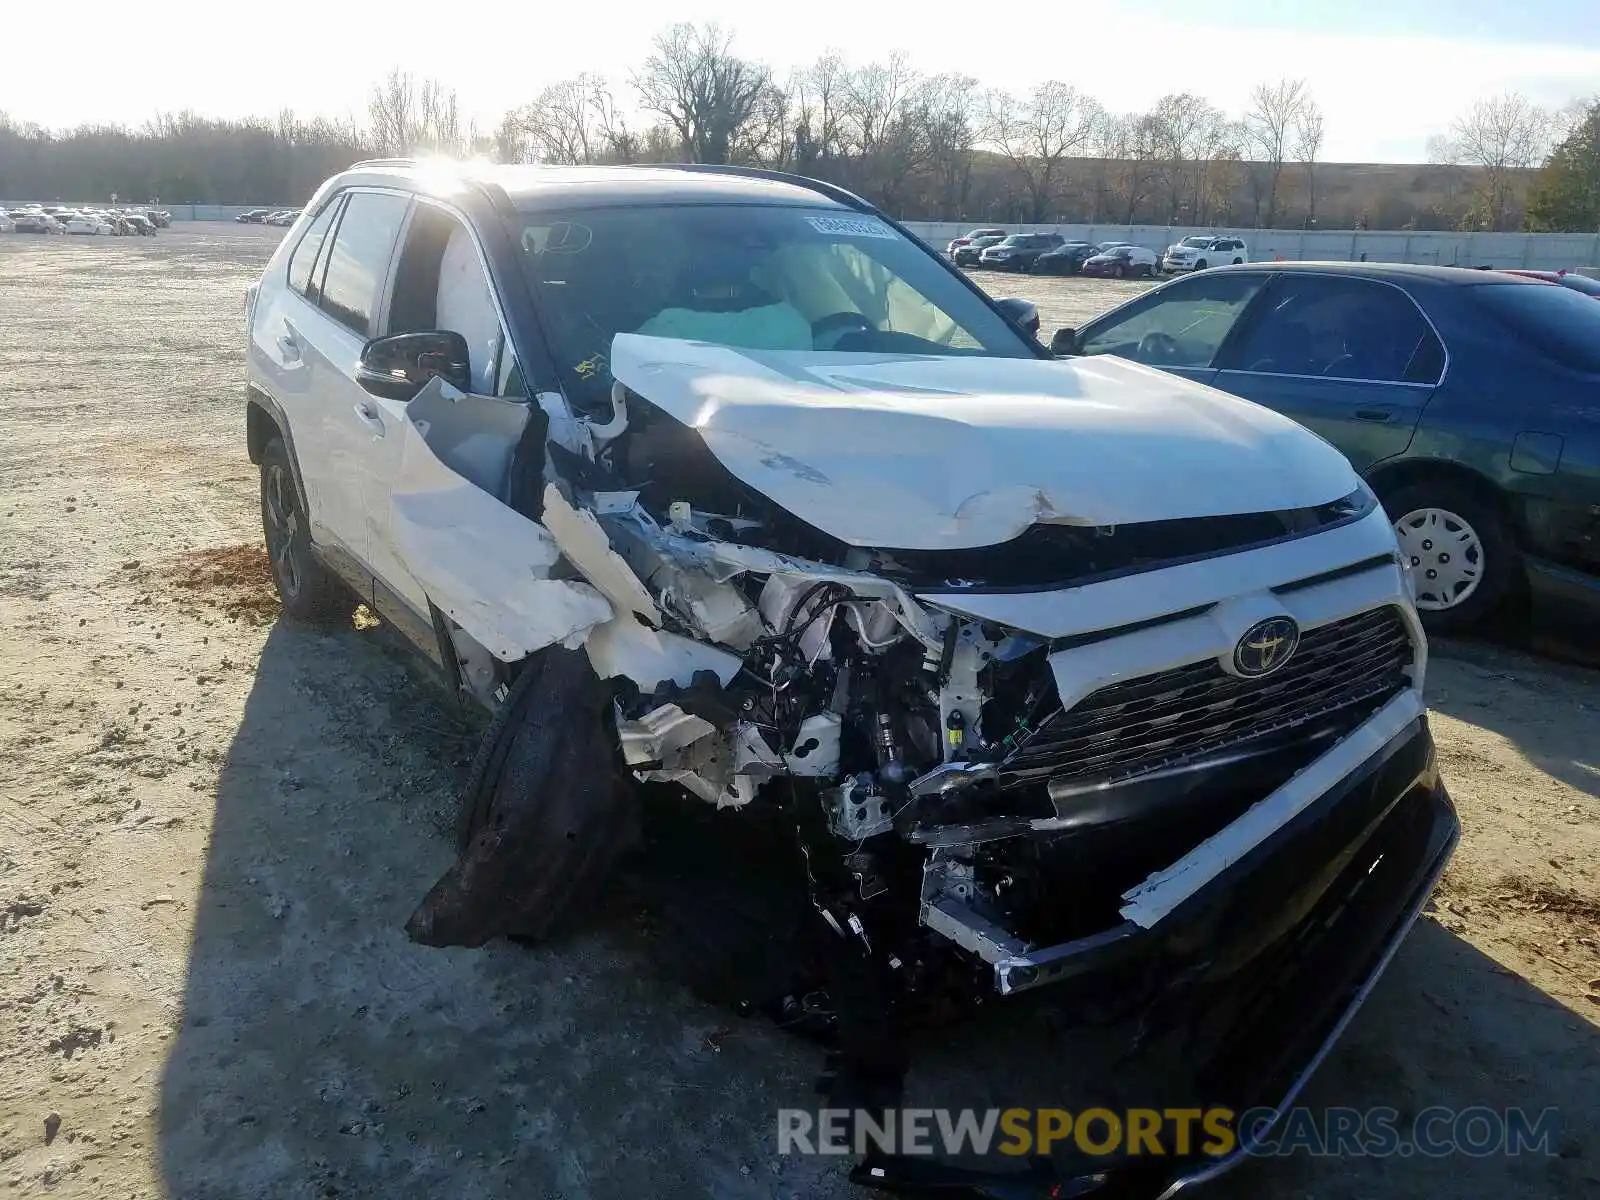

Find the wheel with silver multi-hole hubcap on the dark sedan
[[1384, 480, 1522, 632]]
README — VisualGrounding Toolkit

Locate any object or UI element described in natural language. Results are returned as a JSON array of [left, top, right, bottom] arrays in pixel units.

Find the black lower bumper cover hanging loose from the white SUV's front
[[853, 715, 1461, 1200]]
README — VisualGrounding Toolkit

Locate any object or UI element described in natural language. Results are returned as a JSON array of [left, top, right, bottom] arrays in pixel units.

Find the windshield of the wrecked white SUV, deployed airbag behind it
[[518, 205, 1034, 403]]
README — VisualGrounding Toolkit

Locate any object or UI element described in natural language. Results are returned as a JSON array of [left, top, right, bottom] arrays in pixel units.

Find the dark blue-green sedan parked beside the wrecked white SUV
[[1051, 262, 1600, 630]]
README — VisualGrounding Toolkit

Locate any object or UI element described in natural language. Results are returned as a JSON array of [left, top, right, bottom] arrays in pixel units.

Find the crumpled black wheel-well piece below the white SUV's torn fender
[[406, 648, 638, 946]]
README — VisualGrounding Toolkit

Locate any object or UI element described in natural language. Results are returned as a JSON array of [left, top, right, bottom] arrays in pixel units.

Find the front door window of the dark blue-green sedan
[[1080, 274, 1264, 366]]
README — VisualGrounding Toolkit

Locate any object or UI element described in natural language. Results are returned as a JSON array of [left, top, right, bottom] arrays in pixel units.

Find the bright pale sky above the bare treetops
[[9, 0, 1600, 162]]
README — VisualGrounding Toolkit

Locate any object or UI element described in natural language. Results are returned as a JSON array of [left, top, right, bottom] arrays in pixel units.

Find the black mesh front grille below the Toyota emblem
[[1000, 606, 1411, 786]]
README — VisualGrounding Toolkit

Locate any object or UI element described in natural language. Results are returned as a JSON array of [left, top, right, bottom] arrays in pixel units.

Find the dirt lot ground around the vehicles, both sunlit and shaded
[[0, 226, 1600, 1200]]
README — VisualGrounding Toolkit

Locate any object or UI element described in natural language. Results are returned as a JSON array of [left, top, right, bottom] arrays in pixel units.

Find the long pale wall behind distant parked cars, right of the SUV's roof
[[906, 221, 1600, 270]]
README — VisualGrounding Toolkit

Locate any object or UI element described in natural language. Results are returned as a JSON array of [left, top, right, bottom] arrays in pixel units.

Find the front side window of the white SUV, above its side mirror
[[384, 203, 506, 395]]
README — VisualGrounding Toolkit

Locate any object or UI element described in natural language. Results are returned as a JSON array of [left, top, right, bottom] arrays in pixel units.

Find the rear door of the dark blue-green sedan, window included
[[1213, 272, 1445, 472]]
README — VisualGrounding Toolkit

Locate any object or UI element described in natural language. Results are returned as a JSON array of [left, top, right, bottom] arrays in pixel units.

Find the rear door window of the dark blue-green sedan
[[1230, 275, 1443, 382]]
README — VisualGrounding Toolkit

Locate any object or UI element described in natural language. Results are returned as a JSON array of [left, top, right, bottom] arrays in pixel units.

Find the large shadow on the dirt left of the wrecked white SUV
[[158, 622, 851, 1200]]
